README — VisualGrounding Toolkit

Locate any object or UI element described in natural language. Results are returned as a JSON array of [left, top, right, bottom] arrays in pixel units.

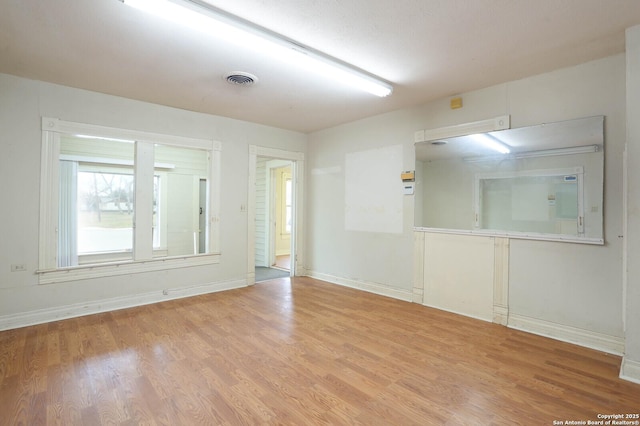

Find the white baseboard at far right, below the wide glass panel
[[507, 313, 624, 355]]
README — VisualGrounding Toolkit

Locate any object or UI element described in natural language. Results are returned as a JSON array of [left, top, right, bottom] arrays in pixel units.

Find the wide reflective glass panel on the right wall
[[414, 116, 605, 245]]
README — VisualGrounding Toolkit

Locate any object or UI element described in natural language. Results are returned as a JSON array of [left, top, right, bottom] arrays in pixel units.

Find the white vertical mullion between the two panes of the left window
[[133, 142, 154, 260]]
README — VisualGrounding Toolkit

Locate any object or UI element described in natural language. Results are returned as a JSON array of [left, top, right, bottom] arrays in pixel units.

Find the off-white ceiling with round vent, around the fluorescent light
[[0, 0, 640, 132]]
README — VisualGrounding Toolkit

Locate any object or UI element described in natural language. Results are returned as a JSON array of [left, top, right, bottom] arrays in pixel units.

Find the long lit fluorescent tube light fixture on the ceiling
[[120, 0, 393, 97]]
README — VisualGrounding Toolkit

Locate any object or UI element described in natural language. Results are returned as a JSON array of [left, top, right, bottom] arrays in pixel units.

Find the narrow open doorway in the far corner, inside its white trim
[[247, 146, 304, 285]]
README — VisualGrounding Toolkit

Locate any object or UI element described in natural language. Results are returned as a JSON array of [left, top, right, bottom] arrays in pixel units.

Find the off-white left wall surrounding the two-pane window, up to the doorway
[[0, 75, 307, 328]]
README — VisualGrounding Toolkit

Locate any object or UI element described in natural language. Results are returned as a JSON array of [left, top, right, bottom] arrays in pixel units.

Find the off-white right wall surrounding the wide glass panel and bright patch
[[307, 55, 625, 352]]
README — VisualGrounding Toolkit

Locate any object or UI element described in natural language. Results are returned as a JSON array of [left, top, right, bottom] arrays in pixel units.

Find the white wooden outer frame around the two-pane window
[[37, 117, 222, 284]]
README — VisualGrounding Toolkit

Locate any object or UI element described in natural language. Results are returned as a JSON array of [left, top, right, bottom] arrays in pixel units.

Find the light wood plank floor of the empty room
[[0, 278, 640, 425]]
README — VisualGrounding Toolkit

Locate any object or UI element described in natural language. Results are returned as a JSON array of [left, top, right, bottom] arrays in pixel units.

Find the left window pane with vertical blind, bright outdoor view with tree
[[58, 136, 134, 267]]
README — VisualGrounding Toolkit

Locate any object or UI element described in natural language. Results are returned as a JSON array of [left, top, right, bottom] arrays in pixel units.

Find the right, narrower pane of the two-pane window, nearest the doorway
[[154, 145, 209, 256]]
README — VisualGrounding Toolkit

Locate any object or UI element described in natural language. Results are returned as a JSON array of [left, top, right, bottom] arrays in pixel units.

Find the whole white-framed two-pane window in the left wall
[[40, 118, 220, 283]]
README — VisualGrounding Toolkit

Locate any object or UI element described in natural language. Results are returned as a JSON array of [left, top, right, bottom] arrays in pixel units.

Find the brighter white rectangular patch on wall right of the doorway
[[345, 145, 404, 234]]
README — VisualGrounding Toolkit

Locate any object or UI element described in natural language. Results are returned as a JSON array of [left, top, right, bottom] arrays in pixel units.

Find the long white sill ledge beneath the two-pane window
[[37, 253, 220, 284]]
